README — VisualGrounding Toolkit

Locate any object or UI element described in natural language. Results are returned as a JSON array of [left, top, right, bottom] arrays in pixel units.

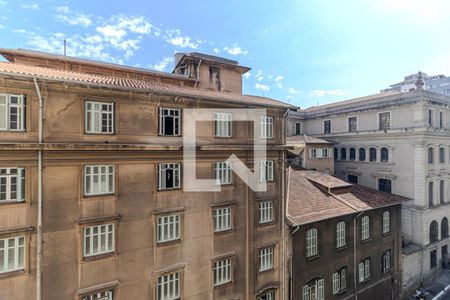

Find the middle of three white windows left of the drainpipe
[[0, 168, 25, 203]]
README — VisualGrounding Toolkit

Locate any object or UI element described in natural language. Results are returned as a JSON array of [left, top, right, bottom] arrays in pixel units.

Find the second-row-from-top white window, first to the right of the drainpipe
[[84, 165, 114, 196]]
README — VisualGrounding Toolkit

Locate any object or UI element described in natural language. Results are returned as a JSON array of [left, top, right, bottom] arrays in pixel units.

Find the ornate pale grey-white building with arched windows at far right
[[288, 89, 450, 290]]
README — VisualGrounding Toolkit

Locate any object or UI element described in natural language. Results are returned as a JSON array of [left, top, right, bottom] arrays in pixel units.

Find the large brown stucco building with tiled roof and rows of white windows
[[0, 49, 291, 300]]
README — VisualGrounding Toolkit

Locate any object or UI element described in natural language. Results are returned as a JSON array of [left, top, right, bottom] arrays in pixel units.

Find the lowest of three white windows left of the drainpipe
[[0, 236, 25, 274]]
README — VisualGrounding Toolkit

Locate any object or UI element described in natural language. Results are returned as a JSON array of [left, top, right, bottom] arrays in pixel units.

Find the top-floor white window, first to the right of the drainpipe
[[85, 101, 114, 134]]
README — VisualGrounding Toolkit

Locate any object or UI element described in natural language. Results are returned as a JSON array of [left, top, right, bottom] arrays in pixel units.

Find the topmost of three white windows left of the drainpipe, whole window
[[0, 94, 25, 131]]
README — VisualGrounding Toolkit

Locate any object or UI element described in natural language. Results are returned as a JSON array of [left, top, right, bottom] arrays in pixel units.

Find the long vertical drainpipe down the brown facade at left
[[33, 77, 44, 300]]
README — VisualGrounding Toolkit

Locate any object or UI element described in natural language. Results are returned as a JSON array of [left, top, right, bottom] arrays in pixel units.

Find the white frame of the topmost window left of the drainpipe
[[0, 94, 26, 131]]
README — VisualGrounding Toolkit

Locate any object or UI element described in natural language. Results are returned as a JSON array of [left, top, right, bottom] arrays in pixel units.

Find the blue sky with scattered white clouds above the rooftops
[[0, 0, 450, 107]]
